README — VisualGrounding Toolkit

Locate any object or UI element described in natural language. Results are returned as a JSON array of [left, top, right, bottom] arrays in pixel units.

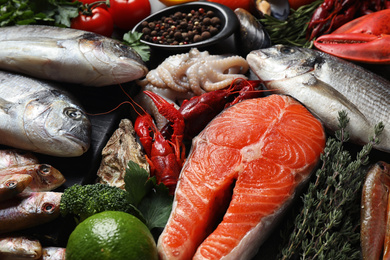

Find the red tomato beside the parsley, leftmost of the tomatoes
[[70, 7, 114, 37]]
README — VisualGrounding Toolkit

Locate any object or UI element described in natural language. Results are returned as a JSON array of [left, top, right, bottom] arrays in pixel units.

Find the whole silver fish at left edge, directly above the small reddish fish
[[0, 71, 91, 157]]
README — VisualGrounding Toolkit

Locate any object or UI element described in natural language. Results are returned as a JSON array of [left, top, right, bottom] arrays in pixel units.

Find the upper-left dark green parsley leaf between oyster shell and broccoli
[[124, 161, 156, 207]]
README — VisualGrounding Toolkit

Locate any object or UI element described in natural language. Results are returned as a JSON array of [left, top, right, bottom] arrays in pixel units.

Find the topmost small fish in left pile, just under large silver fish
[[0, 149, 39, 169]]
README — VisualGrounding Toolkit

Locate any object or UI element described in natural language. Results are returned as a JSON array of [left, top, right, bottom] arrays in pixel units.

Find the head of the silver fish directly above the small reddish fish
[[23, 90, 92, 157]]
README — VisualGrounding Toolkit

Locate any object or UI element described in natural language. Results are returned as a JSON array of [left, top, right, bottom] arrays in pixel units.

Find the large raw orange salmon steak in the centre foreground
[[158, 95, 326, 260]]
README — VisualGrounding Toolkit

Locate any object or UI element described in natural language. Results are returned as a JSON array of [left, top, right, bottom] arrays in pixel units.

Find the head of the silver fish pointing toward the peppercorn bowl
[[79, 33, 148, 86]]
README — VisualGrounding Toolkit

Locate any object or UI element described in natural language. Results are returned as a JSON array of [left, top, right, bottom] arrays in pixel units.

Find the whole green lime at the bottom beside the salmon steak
[[66, 211, 158, 260]]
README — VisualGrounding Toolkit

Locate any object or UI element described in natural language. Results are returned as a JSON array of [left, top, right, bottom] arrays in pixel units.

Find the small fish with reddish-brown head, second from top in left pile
[[0, 164, 65, 191]]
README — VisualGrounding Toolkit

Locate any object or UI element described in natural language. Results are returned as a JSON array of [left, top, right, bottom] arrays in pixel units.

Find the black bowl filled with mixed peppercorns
[[133, 2, 239, 51]]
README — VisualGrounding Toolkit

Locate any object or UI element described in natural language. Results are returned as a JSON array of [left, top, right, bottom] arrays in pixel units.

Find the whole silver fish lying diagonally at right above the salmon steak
[[247, 45, 390, 152]]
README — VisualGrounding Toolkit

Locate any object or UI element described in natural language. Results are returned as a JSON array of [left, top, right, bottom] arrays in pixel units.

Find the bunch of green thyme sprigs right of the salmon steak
[[280, 111, 384, 260]]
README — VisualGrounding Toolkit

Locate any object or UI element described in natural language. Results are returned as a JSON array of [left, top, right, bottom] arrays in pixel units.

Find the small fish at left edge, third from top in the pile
[[0, 174, 33, 201]]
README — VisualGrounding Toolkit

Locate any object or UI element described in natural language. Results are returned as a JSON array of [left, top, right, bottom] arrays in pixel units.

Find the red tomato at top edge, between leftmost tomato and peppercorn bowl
[[108, 0, 151, 31]]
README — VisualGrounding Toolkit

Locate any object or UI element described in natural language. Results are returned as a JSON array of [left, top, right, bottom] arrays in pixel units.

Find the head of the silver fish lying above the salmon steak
[[246, 45, 321, 81]]
